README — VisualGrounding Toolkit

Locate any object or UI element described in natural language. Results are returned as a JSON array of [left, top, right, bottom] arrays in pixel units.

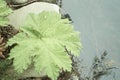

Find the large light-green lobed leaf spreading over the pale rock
[[8, 12, 81, 80]]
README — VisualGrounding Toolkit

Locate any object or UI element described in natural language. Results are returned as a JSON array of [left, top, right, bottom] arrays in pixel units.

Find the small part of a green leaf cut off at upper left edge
[[0, 0, 12, 26]]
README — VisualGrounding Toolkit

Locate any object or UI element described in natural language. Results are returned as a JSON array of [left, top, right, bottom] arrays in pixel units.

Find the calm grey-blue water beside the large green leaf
[[62, 0, 120, 80]]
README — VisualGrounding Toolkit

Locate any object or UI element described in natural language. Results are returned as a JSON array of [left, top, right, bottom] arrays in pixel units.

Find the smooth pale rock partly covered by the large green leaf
[[8, 2, 59, 28]]
